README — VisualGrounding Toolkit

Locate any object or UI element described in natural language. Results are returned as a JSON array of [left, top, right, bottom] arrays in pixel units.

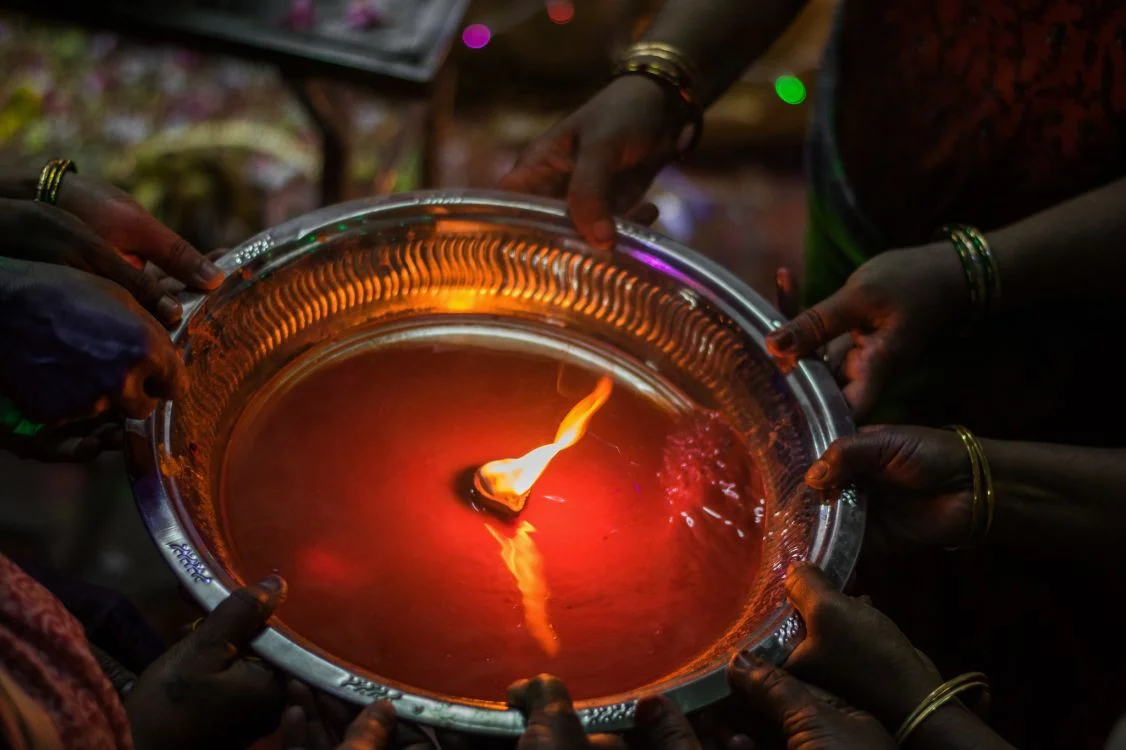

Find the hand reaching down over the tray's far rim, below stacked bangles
[[500, 75, 687, 249]]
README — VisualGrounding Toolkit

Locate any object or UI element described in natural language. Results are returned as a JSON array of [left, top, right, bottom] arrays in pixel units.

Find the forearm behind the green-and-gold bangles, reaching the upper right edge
[[986, 179, 1126, 310]]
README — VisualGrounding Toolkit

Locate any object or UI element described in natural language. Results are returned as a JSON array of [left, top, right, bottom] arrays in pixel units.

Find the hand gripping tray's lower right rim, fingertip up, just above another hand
[[774, 566, 942, 727]]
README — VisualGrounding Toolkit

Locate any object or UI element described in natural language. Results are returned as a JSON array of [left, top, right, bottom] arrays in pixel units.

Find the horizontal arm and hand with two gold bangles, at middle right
[[806, 427, 1126, 565]]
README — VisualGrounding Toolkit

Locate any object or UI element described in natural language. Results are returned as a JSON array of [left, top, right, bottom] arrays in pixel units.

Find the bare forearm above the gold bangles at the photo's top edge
[[644, 0, 805, 106]]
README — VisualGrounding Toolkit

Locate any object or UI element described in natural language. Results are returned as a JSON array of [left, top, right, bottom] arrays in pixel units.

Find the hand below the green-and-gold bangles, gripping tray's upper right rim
[[767, 243, 969, 420]]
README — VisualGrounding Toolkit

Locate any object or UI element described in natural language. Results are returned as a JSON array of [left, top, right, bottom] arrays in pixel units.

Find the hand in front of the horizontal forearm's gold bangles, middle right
[[805, 426, 973, 548]]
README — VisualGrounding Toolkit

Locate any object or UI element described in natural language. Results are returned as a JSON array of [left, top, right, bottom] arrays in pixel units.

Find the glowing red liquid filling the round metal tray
[[223, 346, 762, 700]]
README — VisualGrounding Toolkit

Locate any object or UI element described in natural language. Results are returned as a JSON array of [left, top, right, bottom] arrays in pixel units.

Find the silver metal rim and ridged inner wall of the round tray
[[128, 191, 865, 734]]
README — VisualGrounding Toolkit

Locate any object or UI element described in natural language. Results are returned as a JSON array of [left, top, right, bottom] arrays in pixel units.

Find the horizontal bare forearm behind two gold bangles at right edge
[[982, 440, 1126, 562]]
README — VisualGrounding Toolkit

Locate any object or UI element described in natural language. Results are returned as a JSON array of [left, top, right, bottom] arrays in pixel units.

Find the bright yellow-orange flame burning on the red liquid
[[473, 375, 614, 515]]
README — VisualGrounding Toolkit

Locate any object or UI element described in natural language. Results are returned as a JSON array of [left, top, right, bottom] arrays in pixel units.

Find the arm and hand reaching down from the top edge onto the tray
[[501, 0, 805, 249]]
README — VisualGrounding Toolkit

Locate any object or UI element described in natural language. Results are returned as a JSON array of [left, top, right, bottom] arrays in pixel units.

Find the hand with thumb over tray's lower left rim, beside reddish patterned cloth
[[125, 575, 286, 750]]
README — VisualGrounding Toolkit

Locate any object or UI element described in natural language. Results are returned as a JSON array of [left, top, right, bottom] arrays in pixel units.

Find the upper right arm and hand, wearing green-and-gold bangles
[[767, 180, 1126, 420]]
